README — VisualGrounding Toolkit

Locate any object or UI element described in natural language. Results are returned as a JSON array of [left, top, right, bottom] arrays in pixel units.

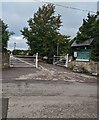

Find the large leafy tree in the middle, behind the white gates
[[21, 4, 70, 62]]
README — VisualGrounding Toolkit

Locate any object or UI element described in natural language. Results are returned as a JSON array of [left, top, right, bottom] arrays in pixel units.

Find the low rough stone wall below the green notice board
[[69, 60, 99, 75]]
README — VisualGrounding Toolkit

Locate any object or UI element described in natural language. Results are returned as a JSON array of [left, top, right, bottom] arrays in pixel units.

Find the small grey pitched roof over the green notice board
[[71, 38, 94, 47]]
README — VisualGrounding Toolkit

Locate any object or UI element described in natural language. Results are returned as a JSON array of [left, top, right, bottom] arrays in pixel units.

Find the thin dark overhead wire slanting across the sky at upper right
[[35, 0, 97, 14]]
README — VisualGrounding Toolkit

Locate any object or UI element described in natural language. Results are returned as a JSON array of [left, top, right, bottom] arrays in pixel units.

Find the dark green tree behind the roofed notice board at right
[[74, 13, 99, 61]]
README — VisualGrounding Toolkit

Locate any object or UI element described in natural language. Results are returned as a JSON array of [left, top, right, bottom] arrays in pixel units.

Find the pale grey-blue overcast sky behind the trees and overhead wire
[[2, 2, 97, 49]]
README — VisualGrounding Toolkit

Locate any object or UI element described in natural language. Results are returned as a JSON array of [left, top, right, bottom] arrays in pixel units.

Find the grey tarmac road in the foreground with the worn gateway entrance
[[2, 55, 97, 119]]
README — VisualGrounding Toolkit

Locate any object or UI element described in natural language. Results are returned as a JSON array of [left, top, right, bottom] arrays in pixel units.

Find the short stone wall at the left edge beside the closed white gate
[[2, 52, 10, 68]]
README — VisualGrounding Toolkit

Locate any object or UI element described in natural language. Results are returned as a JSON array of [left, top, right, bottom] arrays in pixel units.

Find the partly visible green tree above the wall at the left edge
[[0, 19, 14, 52]]
